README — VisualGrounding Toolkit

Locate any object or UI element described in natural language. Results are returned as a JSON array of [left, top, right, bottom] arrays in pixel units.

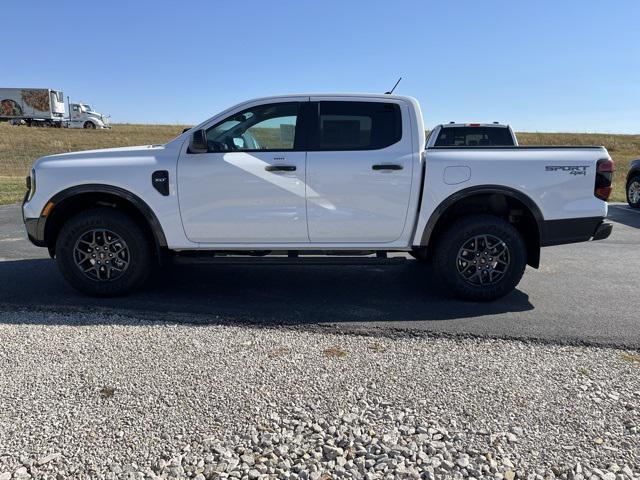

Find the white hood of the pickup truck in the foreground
[[33, 145, 165, 169]]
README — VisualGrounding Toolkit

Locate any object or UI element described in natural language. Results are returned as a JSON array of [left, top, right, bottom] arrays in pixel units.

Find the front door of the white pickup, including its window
[[178, 99, 309, 244]]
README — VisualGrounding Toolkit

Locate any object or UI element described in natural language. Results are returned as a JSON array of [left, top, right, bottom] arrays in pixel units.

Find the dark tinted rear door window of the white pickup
[[313, 102, 402, 150]]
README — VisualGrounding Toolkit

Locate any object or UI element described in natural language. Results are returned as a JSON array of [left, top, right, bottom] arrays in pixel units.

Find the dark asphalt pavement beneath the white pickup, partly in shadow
[[0, 205, 640, 348]]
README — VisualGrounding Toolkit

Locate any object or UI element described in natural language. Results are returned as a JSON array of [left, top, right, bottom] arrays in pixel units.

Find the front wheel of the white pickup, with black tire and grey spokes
[[56, 208, 151, 296]]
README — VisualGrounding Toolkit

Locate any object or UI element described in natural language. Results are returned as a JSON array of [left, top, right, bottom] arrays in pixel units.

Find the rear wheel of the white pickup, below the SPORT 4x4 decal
[[434, 215, 527, 301]]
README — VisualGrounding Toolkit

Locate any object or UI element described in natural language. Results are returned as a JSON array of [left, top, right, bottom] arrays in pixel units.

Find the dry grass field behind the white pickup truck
[[0, 123, 640, 204]]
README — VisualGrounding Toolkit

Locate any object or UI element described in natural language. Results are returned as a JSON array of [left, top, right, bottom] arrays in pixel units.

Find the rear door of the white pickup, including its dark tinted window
[[307, 97, 413, 243]]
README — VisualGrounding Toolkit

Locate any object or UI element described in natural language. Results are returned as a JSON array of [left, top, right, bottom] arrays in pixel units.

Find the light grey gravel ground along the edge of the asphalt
[[0, 311, 640, 480]]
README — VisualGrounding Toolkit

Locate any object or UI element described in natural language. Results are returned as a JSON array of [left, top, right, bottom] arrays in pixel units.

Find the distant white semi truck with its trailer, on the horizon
[[0, 88, 111, 129]]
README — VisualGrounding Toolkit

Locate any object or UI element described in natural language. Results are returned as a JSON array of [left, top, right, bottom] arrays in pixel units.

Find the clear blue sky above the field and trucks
[[0, 0, 640, 133]]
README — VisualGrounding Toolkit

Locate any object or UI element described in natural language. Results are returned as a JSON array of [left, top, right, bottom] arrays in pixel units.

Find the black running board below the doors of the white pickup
[[172, 255, 408, 265]]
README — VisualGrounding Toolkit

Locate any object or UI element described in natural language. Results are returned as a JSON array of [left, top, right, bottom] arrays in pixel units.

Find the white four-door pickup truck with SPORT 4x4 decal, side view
[[23, 94, 613, 301]]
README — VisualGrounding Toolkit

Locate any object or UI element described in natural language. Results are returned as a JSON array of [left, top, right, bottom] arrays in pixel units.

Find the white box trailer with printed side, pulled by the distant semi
[[0, 88, 65, 127]]
